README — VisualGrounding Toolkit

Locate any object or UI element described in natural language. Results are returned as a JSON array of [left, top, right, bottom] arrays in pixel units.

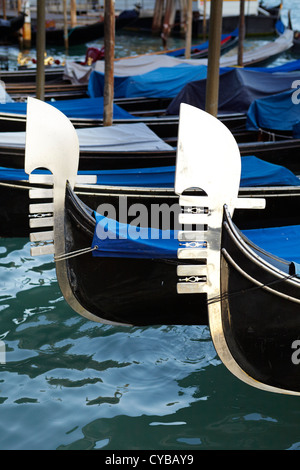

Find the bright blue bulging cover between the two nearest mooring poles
[[88, 63, 207, 98]]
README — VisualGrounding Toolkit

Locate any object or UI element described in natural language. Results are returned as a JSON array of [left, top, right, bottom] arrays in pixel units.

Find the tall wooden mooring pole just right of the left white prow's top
[[103, 0, 115, 126]]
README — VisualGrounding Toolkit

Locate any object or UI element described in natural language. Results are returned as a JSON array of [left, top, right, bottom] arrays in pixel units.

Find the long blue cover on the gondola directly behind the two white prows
[[0, 156, 300, 188]]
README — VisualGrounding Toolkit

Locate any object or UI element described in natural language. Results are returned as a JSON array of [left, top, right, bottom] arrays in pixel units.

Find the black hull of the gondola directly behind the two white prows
[[0, 164, 300, 238]]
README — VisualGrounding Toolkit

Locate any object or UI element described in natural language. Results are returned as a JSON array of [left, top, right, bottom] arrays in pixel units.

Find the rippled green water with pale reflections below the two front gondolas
[[0, 239, 299, 450]]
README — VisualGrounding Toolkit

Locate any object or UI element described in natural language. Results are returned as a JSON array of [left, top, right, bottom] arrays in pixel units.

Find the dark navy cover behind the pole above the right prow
[[167, 68, 298, 115]]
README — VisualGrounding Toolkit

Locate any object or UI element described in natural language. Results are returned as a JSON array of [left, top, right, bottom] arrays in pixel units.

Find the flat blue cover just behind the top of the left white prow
[[0, 98, 133, 119]]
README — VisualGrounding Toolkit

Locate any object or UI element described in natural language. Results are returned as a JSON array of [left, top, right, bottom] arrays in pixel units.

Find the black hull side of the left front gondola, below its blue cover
[[65, 185, 208, 326]]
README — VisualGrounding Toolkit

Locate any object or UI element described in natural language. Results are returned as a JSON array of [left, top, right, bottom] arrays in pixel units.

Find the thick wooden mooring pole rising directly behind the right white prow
[[205, 0, 223, 117]]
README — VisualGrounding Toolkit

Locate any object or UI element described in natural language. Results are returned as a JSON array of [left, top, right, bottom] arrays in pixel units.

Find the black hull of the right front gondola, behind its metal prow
[[220, 207, 300, 393]]
